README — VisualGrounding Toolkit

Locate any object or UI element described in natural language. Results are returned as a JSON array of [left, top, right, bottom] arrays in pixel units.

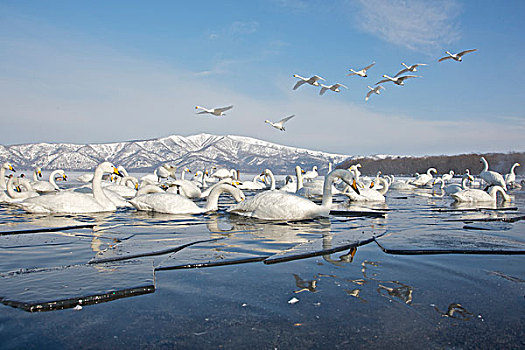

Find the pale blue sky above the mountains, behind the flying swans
[[0, 0, 525, 155]]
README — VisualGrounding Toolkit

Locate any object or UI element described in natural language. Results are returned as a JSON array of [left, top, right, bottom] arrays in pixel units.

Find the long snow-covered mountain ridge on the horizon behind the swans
[[0, 134, 351, 173]]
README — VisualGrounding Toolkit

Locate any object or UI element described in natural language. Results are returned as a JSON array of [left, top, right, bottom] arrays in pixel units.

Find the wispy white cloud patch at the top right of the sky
[[355, 0, 461, 52]]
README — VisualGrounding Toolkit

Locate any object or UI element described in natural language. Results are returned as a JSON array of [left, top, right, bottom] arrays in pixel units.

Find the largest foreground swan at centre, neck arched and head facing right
[[228, 169, 353, 220]]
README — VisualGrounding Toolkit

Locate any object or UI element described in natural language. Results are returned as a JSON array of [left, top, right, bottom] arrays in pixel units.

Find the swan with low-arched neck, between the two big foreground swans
[[129, 184, 245, 214]]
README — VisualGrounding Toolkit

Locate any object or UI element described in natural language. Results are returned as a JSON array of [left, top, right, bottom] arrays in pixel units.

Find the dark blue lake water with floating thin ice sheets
[[0, 176, 525, 349]]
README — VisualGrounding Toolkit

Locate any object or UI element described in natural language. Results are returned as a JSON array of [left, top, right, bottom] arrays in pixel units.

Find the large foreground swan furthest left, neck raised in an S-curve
[[17, 162, 120, 214]]
